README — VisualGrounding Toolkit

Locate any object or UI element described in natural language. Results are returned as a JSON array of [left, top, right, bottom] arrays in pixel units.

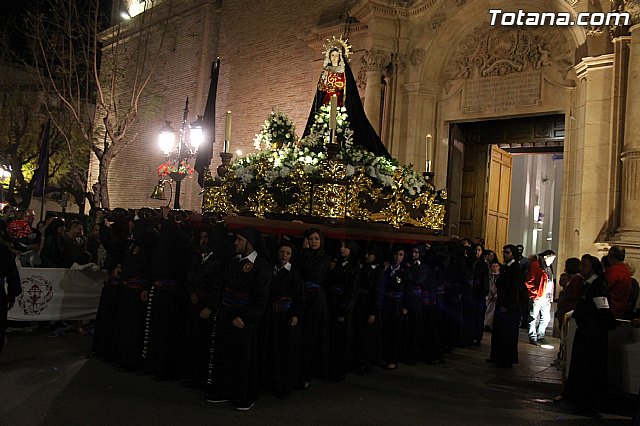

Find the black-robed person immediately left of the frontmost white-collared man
[[182, 229, 222, 388]]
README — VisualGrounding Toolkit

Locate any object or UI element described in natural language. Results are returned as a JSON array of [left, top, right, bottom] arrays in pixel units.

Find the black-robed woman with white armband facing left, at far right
[[563, 254, 616, 417]]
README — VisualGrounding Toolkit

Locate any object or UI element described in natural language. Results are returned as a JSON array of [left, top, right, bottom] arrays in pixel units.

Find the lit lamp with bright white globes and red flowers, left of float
[[152, 98, 204, 209]]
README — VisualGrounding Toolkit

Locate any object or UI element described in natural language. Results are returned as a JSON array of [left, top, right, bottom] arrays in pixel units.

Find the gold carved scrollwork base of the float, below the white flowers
[[203, 156, 446, 230]]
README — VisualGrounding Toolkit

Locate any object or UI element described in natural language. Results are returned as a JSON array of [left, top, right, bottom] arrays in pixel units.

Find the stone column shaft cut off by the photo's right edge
[[618, 24, 640, 243]]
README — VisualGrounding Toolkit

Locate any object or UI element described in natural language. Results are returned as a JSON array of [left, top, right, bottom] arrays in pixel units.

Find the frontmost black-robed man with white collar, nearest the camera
[[205, 228, 273, 411]]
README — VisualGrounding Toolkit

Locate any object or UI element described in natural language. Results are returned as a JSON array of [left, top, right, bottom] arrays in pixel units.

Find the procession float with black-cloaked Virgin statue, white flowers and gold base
[[203, 37, 446, 243]]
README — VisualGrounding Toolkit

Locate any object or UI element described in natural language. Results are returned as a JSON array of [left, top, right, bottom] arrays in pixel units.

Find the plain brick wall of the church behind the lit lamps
[[99, 0, 364, 210]]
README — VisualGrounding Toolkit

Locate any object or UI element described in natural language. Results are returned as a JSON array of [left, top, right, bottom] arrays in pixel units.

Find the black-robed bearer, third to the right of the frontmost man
[[327, 241, 360, 381]]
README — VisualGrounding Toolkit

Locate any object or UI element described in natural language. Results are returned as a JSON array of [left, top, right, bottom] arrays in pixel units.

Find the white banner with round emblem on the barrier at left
[[8, 268, 107, 321]]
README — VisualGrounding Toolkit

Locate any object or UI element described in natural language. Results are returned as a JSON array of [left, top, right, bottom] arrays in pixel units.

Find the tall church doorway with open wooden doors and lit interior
[[445, 114, 565, 260]]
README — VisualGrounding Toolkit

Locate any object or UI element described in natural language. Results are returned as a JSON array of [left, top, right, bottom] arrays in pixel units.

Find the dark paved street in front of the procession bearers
[[0, 333, 636, 426]]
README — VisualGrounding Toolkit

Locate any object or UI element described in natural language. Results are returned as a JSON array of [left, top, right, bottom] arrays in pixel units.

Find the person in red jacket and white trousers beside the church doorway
[[525, 250, 556, 345]]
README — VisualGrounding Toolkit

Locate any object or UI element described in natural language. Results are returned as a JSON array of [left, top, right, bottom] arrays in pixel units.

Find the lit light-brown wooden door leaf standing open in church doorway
[[485, 145, 512, 253]]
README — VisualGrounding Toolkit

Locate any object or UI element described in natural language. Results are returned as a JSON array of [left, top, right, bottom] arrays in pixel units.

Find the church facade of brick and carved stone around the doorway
[[105, 0, 640, 270]]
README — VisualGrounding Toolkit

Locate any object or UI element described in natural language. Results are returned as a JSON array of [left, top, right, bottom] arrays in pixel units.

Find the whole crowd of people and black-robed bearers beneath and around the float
[[0, 203, 638, 416]]
